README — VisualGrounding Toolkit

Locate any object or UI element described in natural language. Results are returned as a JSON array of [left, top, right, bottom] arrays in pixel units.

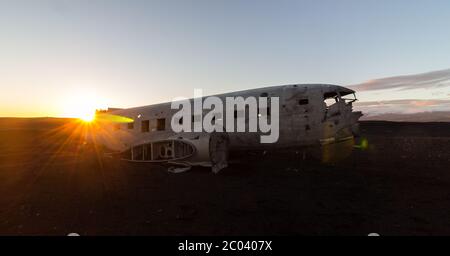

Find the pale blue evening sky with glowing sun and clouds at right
[[0, 0, 450, 117]]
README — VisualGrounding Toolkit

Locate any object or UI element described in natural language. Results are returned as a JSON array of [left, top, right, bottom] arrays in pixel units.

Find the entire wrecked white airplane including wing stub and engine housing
[[92, 84, 362, 173]]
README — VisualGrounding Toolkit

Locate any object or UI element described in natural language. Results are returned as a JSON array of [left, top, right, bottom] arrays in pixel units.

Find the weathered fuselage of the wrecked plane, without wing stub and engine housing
[[96, 84, 361, 171]]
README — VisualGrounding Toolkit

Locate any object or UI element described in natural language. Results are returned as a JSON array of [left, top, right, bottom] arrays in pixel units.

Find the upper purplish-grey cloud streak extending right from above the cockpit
[[349, 69, 450, 91]]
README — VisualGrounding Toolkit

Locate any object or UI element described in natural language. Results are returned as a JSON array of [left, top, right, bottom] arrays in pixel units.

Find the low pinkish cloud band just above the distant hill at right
[[354, 99, 450, 116]]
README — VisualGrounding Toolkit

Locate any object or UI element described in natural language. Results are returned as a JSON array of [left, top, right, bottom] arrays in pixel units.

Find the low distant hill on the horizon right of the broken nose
[[361, 111, 450, 122]]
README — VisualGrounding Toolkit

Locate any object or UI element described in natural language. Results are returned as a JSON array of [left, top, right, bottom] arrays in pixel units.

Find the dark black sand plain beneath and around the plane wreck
[[0, 119, 450, 235]]
